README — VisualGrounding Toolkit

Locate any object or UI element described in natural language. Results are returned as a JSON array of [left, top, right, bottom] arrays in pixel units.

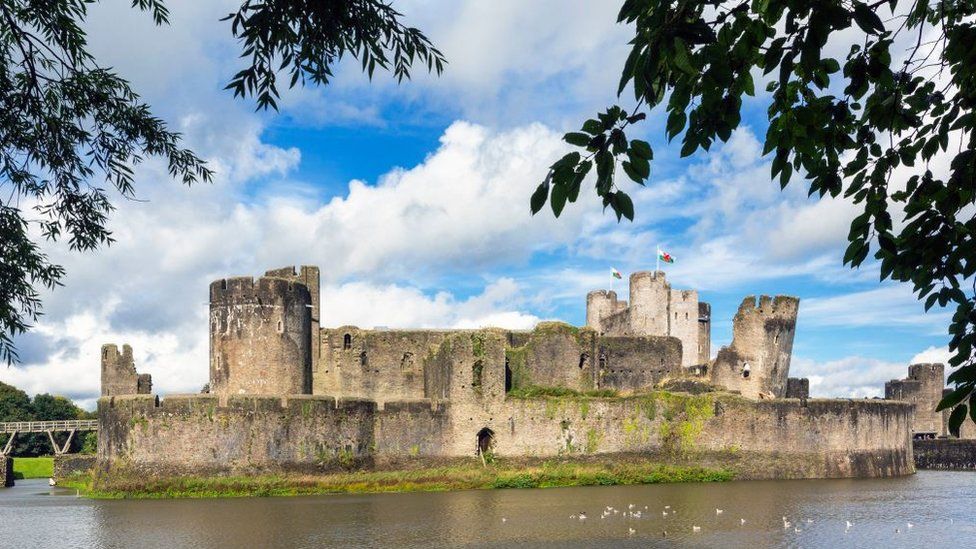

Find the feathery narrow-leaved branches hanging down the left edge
[[0, 0, 212, 364]]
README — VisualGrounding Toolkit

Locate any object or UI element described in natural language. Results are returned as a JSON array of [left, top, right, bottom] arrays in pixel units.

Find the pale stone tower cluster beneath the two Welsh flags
[[586, 271, 711, 367]]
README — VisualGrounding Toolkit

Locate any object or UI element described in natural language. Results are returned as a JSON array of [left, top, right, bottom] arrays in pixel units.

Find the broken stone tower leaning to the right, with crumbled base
[[712, 295, 800, 398]]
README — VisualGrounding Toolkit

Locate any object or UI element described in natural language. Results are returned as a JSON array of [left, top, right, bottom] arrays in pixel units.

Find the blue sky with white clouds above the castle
[[0, 0, 951, 409]]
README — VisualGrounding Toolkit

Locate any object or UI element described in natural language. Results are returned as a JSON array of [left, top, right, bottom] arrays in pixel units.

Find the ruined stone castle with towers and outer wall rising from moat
[[98, 266, 914, 478]]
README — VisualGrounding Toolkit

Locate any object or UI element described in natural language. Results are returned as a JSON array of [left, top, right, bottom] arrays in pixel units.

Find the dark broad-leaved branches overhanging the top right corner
[[531, 0, 976, 432]]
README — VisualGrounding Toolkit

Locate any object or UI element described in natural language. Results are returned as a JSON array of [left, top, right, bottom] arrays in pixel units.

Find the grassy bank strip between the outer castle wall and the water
[[66, 460, 735, 498]]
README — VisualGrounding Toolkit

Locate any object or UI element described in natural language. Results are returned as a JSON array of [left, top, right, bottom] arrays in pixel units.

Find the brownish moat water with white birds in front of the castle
[[0, 471, 976, 548]]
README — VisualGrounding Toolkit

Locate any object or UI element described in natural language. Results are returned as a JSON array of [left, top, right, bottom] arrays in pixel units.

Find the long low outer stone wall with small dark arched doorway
[[99, 393, 914, 478]]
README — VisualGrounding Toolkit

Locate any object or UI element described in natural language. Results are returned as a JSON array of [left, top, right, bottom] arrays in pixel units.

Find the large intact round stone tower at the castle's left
[[210, 277, 312, 395]]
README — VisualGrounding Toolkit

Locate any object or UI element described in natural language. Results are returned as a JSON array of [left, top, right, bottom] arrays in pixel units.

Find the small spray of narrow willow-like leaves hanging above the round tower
[[224, 0, 445, 110]]
